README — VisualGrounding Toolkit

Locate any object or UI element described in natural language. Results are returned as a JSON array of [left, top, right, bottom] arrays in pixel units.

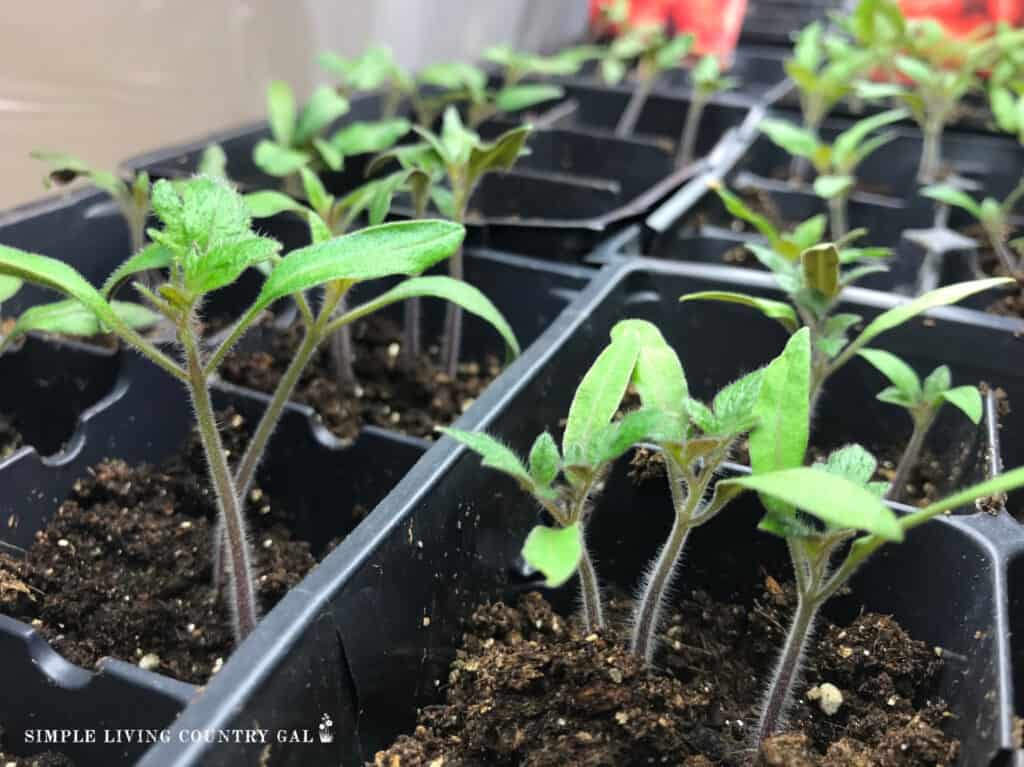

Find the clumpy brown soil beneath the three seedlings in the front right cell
[[373, 589, 958, 767]]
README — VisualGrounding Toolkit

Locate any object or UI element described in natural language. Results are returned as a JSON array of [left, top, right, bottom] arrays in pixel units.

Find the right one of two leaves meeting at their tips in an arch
[[611, 319, 689, 441]]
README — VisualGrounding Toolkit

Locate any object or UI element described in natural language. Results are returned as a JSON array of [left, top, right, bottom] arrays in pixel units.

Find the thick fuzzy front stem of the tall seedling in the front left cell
[[178, 317, 259, 643]]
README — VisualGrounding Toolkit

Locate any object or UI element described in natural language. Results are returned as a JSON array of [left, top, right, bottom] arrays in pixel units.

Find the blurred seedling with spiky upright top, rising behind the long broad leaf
[[368, 106, 530, 378]]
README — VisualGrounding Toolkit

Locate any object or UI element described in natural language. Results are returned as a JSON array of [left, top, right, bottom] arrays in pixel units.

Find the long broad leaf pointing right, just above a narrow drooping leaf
[[249, 220, 466, 313]]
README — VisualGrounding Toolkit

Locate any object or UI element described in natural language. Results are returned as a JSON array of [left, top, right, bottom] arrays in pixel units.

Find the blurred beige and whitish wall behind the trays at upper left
[[0, 0, 587, 209]]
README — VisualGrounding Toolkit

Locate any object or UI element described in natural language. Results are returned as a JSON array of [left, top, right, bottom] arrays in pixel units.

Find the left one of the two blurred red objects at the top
[[590, 0, 746, 62]]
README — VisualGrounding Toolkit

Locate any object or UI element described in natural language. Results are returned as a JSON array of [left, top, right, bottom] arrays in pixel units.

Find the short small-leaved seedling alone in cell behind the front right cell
[[858, 349, 982, 501]]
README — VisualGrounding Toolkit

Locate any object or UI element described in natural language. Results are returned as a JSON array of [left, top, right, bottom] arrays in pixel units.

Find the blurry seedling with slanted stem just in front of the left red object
[[601, 24, 693, 136]]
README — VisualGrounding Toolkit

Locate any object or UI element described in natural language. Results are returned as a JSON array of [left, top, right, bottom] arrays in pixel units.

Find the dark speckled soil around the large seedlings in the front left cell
[[0, 413, 315, 684]]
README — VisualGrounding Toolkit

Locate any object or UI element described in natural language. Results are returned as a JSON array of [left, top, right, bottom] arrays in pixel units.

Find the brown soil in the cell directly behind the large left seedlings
[[220, 317, 501, 439]]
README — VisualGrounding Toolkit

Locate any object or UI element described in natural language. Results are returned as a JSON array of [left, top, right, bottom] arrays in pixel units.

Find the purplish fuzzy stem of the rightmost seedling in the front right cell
[[757, 541, 823, 745]]
